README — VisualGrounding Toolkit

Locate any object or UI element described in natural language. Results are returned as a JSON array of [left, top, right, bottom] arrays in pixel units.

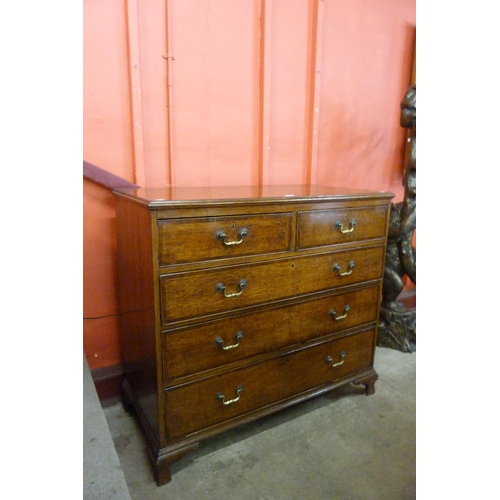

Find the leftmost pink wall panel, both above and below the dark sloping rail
[[83, 0, 134, 369]]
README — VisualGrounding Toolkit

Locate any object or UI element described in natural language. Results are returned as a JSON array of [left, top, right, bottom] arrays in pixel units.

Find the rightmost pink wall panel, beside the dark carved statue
[[318, 0, 415, 199]]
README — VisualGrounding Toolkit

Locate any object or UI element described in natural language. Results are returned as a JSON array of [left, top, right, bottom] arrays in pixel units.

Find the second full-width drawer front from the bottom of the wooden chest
[[163, 285, 379, 384]]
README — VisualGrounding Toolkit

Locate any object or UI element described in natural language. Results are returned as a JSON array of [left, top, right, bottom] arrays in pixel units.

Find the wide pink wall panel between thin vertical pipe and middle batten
[[171, 0, 260, 186]]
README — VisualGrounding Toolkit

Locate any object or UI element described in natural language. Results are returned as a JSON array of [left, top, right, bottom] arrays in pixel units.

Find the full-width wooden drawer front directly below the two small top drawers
[[160, 246, 384, 325]]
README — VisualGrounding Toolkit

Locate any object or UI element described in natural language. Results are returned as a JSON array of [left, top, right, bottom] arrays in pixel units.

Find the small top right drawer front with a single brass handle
[[297, 206, 387, 249]]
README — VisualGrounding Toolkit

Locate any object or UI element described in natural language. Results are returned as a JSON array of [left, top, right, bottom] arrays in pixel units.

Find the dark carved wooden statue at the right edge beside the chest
[[377, 85, 417, 352]]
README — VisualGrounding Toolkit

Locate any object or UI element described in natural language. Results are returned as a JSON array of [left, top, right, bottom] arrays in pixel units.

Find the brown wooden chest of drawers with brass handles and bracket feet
[[114, 186, 393, 485]]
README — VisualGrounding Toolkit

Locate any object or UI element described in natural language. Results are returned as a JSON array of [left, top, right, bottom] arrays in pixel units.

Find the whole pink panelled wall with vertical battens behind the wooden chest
[[83, 0, 416, 369]]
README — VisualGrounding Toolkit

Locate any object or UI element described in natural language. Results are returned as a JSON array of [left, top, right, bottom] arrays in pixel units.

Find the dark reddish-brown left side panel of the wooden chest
[[115, 198, 164, 442]]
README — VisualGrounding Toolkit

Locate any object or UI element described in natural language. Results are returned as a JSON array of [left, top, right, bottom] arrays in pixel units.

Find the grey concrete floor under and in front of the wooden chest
[[104, 347, 416, 500]]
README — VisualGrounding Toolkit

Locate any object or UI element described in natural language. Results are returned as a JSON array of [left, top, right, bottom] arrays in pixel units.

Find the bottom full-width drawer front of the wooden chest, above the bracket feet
[[165, 329, 375, 438]]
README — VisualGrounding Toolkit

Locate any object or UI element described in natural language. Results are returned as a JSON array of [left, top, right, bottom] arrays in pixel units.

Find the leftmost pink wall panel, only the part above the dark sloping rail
[[83, 0, 134, 180]]
